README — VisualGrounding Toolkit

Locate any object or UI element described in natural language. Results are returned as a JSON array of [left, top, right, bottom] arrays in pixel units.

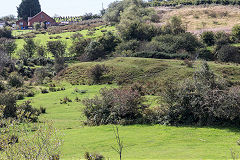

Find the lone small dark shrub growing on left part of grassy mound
[[88, 64, 108, 84]]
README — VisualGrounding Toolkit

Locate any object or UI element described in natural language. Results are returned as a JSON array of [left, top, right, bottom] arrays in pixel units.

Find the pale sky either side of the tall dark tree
[[0, 0, 115, 17]]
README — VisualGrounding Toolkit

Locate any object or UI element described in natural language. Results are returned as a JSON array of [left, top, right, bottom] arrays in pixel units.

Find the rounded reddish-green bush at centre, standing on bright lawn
[[83, 88, 147, 125]]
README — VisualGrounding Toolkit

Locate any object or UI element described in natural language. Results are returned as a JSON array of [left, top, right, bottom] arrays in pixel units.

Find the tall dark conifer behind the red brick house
[[17, 0, 41, 21]]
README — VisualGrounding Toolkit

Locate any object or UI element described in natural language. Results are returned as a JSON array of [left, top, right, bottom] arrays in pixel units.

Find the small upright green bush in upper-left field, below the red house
[[23, 38, 37, 58]]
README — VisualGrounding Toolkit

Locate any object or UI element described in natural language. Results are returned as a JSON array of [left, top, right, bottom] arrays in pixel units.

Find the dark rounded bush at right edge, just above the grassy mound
[[216, 45, 240, 63]]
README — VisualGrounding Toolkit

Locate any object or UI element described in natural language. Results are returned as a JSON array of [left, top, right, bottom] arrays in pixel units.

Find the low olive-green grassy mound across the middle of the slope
[[60, 58, 240, 85]]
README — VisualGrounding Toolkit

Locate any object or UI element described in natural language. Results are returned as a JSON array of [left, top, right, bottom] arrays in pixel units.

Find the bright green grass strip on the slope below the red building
[[13, 26, 115, 52]]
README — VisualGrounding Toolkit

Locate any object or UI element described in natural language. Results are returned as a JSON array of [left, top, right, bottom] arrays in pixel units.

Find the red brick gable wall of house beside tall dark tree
[[28, 12, 56, 26]]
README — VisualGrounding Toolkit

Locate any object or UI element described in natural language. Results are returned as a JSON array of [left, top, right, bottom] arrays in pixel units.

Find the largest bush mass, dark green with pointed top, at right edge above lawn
[[164, 63, 240, 125]]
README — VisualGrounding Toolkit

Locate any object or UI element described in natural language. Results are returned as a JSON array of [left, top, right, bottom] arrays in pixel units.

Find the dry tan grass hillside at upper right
[[155, 5, 240, 33]]
